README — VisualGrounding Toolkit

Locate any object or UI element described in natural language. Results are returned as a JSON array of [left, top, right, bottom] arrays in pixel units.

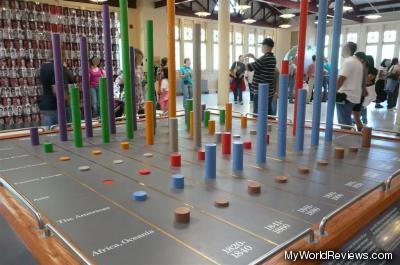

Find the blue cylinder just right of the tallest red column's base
[[295, 89, 307, 152]]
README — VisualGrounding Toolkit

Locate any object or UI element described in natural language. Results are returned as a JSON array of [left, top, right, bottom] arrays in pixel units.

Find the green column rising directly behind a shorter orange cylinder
[[146, 20, 157, 134]]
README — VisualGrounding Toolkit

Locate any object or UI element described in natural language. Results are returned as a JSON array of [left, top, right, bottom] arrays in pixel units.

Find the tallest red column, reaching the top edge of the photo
[[293, 0, 308, 135]]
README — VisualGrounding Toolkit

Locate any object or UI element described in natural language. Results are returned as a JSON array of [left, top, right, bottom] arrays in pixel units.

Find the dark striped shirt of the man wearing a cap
[[250, 52, 276, 97]]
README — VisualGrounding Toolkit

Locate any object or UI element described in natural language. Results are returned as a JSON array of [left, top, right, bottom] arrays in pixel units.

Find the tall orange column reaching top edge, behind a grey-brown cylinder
[[167, 0, 176, 118]]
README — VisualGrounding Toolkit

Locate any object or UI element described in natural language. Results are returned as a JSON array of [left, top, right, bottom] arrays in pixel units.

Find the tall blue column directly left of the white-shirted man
[[325, 0, 343, 142]]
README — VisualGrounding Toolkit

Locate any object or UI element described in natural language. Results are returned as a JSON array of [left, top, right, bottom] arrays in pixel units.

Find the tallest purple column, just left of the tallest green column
[[102, 4, 116, 134]]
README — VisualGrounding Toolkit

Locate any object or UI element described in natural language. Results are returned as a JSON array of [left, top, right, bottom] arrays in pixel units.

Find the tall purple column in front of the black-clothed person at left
[[51, 33, 68, 141]]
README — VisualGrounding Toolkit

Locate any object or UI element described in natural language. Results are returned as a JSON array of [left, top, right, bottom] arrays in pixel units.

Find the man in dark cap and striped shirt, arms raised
[[245, 38, 279, 115]]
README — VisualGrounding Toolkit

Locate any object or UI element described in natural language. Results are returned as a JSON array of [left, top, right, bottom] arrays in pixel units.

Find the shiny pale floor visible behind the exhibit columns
[[177, 92, 400, 131]]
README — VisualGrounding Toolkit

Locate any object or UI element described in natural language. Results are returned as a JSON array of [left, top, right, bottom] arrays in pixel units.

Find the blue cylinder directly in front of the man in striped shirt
[[257, 84, 269, 165]]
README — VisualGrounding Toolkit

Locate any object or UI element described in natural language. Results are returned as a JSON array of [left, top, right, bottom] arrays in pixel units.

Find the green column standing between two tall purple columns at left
[[69, 86, 83, 147]]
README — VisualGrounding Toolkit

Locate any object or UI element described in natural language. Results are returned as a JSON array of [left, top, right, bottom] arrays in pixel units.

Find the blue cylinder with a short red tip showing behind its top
[[276, 74, 289, 157]]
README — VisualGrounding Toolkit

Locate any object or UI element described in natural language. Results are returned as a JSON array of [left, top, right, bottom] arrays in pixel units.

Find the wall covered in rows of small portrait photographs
[[0, 0, 120, 130]]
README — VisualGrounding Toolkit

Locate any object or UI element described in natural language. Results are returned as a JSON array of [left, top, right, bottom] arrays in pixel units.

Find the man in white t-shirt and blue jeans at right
[[336, 42, 363, 125]]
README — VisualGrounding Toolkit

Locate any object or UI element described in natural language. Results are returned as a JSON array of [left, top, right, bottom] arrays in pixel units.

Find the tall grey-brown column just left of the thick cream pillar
[[191, 23, 201, 148]]
